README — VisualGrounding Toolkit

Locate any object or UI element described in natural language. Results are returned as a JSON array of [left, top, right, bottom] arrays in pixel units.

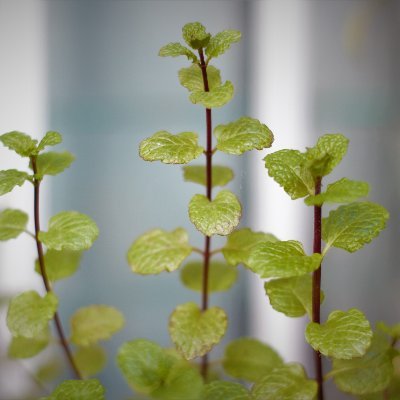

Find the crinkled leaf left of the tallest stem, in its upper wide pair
[[139, 131, 204, 164]]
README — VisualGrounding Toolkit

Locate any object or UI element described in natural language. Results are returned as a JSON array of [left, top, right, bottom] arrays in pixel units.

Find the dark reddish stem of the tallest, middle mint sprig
[[199, 49, 213, 379]]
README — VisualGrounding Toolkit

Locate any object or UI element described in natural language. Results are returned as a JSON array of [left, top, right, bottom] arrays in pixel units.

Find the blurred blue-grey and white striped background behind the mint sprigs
[[0, 0, 400, 400]]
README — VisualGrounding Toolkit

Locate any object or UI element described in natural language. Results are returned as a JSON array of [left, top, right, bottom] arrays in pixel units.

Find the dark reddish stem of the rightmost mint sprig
[[312, 177, 324, 400]]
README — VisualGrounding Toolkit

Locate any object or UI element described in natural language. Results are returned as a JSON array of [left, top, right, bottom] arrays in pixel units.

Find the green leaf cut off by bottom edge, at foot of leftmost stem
[[43, 379, 106, 400]]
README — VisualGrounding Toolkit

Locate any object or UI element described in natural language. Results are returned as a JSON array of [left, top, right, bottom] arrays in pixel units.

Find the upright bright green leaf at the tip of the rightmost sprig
[[306, 134, 349, 177]]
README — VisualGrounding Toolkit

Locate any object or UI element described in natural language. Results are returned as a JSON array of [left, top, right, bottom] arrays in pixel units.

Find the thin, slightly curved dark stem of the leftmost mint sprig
[[31, 156, 83, 379]]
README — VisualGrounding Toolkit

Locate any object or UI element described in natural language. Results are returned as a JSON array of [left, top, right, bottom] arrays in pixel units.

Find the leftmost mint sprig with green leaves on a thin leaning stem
[[0, 131, 124, 399]]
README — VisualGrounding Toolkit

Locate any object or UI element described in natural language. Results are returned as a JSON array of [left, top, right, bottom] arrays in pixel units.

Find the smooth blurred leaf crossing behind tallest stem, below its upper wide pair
[[183, 165, 233, 187]]
